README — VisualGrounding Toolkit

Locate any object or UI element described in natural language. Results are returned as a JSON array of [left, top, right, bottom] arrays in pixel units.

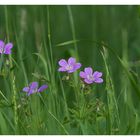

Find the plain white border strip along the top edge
[[0, 0, 140, 5]]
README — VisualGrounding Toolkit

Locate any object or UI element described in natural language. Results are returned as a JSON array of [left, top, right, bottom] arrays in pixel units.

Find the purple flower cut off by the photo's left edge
[[0, 40, 13, 54]]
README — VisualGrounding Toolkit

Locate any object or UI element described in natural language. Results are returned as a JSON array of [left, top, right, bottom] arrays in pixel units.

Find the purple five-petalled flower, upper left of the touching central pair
[[58, 57, 81, 73]]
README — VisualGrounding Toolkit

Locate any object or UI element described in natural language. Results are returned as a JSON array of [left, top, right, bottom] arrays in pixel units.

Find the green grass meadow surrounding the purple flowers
[[0, 5, 140, 135]]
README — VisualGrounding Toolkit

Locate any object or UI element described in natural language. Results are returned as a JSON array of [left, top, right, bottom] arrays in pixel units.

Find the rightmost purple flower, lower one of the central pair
[[80, 67, 103, 84]]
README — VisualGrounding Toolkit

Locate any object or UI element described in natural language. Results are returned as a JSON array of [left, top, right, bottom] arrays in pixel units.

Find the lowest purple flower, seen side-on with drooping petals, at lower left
[[23, 82, 48, 96]]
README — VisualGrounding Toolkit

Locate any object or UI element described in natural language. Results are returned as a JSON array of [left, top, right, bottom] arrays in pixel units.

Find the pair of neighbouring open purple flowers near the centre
[[58, 57, 103, 84]]
